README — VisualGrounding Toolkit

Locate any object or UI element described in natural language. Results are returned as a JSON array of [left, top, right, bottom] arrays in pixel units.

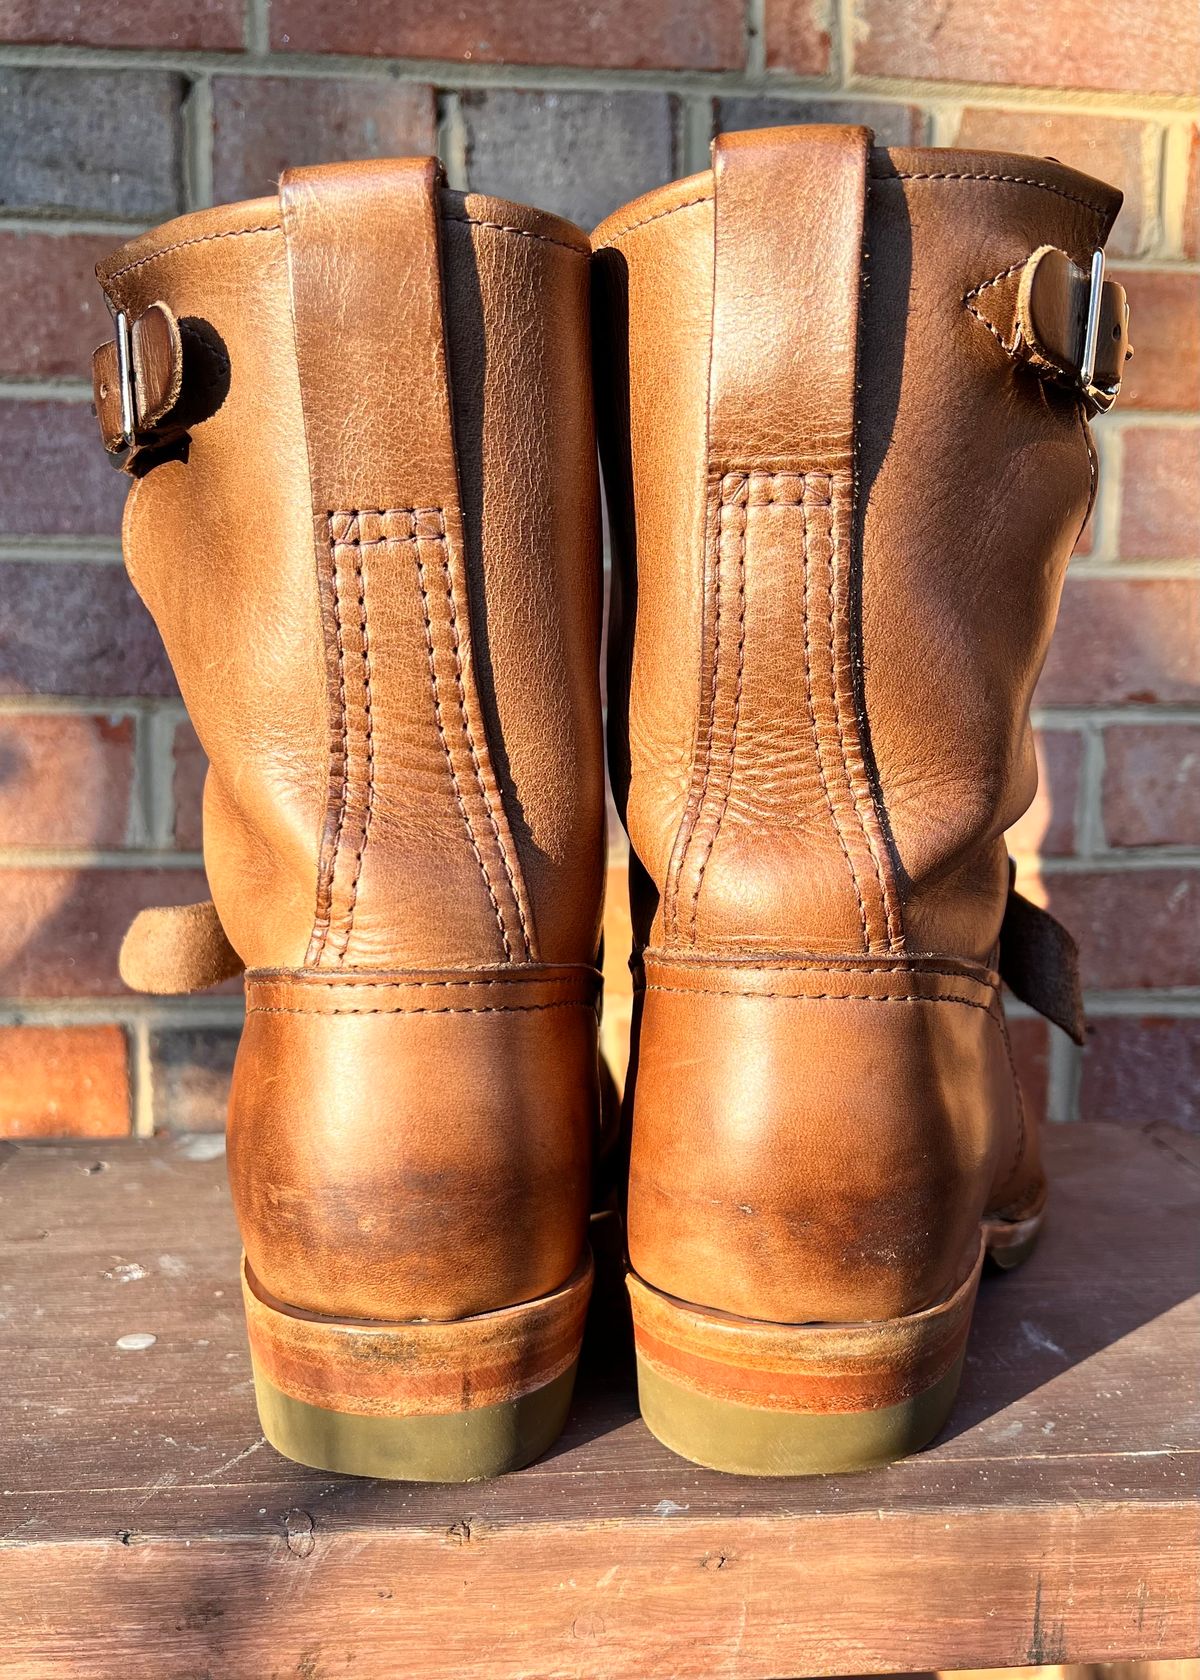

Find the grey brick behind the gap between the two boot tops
[[462, 87, 674, 227]]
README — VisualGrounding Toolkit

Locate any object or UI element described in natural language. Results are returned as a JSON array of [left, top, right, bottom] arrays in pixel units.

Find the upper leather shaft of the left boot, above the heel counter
[[101, 160, 603, 969]]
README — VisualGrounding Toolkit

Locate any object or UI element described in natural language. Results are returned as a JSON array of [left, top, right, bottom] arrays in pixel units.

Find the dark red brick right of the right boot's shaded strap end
[[1024, 867, 1200, 991]]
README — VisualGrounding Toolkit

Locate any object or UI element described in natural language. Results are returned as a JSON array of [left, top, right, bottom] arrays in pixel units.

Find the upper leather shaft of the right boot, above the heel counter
[[593, 129, 1123, 963]]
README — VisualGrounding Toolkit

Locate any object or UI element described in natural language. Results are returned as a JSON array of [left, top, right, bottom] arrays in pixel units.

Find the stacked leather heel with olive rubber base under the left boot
[[242, 1253, 592, 1482]]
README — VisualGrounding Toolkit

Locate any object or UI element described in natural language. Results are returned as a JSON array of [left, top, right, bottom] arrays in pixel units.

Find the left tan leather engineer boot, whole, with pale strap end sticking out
[[96, 160, 603, 1480]]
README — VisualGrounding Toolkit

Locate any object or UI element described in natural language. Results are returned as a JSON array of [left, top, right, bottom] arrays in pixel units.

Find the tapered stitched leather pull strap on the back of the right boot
[[666, 126, 903, 951]]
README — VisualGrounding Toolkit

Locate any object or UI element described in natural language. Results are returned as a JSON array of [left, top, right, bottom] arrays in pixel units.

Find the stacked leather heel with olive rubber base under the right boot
[[629, 1243, 983, 1475]]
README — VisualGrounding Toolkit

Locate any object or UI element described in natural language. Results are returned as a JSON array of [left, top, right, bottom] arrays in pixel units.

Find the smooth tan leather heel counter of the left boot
[[229, 968, 598, 1320]]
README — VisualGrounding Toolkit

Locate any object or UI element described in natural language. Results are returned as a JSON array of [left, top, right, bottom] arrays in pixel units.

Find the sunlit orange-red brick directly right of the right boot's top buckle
[[1113, 269, 1200, 408]]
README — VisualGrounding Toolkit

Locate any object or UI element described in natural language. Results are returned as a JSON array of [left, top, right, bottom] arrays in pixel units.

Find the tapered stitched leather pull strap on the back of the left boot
[[279, 158, 533, 966]]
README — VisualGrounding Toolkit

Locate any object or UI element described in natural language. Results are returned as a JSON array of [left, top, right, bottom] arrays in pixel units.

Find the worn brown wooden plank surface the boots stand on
[[0, 1126, 1200, 1680]]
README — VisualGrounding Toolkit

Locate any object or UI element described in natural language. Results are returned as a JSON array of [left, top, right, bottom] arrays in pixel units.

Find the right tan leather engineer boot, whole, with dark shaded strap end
[[593, 128, 1126, 1473]]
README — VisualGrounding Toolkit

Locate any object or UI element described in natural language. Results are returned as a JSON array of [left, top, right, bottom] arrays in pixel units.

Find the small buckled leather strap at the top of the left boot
[[92, 302, 183, 472]]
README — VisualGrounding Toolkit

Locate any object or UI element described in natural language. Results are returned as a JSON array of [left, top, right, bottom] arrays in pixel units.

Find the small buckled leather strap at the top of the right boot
[[965, 245, 1133, 413]]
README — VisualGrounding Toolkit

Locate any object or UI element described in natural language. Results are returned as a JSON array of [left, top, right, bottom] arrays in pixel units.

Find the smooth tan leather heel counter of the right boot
[[630, 958, 1027, 1324]]
